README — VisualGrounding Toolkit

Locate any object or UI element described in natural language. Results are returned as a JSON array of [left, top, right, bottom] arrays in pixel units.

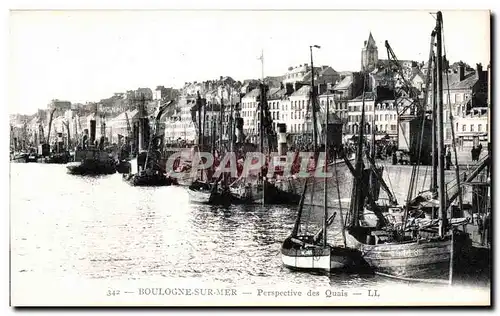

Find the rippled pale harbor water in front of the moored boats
[[10, 163, 488, 288]]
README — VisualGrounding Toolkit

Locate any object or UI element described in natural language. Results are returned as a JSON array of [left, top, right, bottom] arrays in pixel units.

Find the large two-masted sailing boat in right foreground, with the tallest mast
[[345, 12, 469, 282]]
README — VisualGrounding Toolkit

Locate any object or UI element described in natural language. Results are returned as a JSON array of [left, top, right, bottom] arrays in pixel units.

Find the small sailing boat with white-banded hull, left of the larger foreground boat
[[281, 94, 362, 272]]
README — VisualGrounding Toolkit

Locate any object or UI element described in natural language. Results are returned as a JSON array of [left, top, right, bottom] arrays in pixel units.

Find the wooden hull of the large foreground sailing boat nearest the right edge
[[346, 232, 465, 279]]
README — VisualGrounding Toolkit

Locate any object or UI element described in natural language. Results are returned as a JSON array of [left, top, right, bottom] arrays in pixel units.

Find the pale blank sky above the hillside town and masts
[[8, 10, 490, 114]]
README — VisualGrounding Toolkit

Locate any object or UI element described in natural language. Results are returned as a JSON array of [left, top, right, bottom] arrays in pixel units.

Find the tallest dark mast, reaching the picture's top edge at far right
[[436, 11, 447, 237]]
